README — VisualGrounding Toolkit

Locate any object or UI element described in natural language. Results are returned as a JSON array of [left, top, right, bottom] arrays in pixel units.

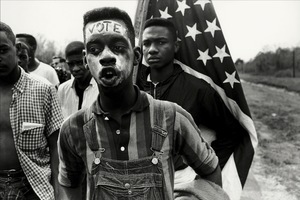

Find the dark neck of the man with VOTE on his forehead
[[99, 80, 137, 119]]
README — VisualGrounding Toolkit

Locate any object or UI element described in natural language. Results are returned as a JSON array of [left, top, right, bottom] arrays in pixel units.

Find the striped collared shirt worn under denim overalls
[[58, 88, 218, 199]]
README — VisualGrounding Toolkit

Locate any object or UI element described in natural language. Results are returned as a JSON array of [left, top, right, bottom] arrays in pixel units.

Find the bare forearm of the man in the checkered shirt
[[48, 130, 59, 199]]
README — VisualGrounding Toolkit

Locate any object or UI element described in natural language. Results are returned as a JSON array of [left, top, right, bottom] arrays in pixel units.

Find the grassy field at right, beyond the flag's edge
[[240, 74, 300, 200]]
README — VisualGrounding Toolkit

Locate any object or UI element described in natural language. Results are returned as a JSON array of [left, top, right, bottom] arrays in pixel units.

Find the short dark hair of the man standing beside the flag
[[143, 18, 177, 40]]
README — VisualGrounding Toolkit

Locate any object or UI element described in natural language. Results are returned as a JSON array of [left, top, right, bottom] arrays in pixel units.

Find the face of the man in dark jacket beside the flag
[[142, 26, 178, 68]]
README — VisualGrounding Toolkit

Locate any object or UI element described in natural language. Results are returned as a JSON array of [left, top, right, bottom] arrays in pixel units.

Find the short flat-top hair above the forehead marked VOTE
[[83, 7, 135, 46]]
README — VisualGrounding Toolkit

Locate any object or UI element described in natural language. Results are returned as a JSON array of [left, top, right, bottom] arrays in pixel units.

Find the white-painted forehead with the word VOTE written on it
[[84, 20, 128, 38]]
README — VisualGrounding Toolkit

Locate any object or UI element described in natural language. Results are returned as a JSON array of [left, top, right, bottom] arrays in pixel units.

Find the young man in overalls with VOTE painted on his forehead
[[58, 7, 221, 200]]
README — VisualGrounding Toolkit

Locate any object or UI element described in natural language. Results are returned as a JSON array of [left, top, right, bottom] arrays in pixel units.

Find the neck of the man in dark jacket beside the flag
[[150, 62, 174, 83]]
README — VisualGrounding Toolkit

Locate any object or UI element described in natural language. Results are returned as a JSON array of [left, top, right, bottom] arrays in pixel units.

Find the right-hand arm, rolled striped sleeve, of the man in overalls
[[174, 104, 222, 186]]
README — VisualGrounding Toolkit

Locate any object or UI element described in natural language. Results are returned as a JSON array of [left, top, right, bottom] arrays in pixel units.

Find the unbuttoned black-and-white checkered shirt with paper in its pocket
[[9, 69, 63, 200]]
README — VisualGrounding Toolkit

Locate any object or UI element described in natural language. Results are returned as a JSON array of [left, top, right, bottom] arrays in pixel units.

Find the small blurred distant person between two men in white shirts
[[51, 56, 71, 84]]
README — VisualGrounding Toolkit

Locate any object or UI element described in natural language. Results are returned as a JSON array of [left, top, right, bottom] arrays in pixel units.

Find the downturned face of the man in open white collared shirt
[[67, 54, 90, 81]]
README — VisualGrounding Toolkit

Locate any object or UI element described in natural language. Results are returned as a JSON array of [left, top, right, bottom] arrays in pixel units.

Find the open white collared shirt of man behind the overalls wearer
[[57, 78, 99, 119]]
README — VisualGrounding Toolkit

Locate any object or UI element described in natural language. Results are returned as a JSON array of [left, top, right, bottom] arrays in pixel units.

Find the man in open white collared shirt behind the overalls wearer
[[57, 41, 99, 119]]
